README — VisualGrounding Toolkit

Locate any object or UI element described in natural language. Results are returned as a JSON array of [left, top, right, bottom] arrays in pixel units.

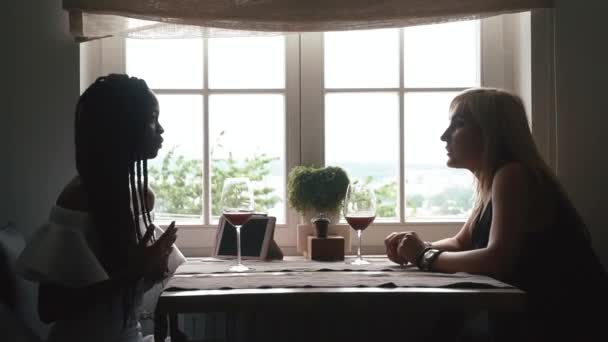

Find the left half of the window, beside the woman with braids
[[125, 37, 286, 225]]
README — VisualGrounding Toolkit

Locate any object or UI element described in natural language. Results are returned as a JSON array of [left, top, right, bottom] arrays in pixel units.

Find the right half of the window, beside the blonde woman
[[323, 21, 480, 222]]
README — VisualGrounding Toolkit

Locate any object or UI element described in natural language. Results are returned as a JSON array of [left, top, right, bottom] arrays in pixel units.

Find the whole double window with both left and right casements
[[82, 19, 524, 254]]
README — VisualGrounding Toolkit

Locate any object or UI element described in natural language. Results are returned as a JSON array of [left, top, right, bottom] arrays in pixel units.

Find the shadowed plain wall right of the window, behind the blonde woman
[[555, 0, 608, 267]]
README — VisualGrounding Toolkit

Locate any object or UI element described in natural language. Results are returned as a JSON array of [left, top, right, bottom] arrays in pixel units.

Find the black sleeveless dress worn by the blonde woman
[[472, 202, 608, 341]]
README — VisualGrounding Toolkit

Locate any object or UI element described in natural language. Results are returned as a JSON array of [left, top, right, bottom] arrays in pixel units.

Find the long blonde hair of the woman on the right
[[450, 88, 561, 213]]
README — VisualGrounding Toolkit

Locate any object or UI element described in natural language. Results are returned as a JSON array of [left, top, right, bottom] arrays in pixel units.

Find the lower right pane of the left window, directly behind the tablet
[[209, 94, 285, 223]]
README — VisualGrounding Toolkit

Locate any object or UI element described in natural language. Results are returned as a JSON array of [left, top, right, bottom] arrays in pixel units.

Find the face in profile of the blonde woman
[[441, 106, 482, 172]]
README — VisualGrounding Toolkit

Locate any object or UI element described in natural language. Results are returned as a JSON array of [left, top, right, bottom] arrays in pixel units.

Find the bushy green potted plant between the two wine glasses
[[287, 165, 349, 237]]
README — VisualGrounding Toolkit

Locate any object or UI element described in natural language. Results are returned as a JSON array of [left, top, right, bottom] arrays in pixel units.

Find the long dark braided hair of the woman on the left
[[75, 74, 158, 324]]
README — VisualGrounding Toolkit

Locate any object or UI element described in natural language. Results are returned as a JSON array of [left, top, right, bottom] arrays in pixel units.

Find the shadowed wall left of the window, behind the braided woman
[[5, 0, 79, 236]]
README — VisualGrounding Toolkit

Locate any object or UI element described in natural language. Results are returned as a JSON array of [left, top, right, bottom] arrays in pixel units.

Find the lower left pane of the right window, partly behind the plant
[[325, 93, 399, 220]]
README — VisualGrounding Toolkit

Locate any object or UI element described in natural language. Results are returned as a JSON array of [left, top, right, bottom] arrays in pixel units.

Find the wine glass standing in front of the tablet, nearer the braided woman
[[220, 177, 255, 272]]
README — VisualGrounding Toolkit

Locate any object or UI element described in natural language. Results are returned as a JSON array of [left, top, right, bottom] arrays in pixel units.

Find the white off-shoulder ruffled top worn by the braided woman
[[15, 205, 186, 342]]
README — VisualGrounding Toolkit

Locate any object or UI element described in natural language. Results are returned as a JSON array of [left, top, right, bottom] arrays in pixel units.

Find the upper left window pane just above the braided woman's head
[[126, 39, 203, 89]]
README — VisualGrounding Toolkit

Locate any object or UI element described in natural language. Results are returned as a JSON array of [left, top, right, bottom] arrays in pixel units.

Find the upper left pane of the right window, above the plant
[[324, 29, 399, 88]]
